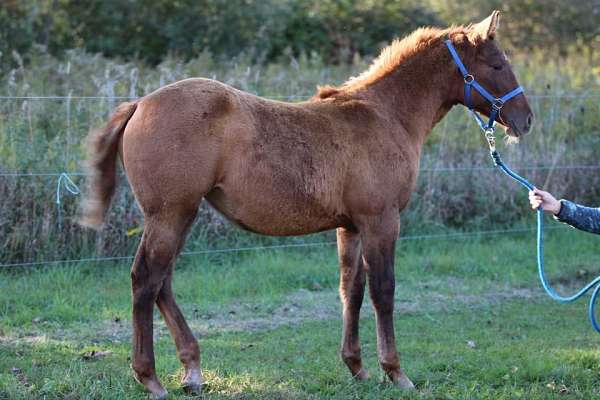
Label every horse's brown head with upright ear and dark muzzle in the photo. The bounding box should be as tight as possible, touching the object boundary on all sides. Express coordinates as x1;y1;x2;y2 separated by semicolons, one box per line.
452;11;533;137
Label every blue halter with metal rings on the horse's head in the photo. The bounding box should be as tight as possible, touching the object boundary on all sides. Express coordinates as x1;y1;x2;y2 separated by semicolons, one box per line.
444;39;523;148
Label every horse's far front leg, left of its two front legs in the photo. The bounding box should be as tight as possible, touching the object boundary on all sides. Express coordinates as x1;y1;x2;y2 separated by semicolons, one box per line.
337;228;368;380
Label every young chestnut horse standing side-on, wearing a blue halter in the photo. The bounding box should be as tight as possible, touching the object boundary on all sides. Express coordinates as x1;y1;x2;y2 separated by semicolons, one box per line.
81;11;533;398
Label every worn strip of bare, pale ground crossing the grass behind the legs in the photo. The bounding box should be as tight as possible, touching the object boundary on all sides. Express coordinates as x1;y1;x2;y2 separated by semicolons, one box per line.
3;281;542;344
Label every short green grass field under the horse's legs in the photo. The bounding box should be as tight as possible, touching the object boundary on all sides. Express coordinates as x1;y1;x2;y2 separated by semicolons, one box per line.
0;225;600;399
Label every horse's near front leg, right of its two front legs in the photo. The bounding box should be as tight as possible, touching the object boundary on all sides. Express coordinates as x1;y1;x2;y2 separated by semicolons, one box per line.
359;214;414;389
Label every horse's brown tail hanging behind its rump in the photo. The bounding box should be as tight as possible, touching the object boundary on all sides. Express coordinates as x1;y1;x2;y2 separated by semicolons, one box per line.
79;102;137;229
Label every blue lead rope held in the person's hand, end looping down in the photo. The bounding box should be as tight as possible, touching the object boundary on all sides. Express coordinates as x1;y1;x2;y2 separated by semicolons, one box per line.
490;148;600;333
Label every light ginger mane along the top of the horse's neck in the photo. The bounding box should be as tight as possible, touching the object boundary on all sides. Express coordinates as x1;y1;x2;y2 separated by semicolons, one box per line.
315;26;469;99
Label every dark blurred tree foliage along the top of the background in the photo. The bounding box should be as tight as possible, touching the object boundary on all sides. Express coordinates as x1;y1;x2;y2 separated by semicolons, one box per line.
0;0;600;70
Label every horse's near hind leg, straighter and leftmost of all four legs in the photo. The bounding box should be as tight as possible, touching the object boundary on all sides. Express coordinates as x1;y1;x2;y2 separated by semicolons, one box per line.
131;207;199;398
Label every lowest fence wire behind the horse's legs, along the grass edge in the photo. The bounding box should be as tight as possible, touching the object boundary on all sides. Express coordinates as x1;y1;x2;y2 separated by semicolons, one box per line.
0;226;567;268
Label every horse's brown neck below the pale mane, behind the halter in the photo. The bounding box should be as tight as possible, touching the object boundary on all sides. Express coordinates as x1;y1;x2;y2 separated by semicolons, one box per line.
367;47;457;146
